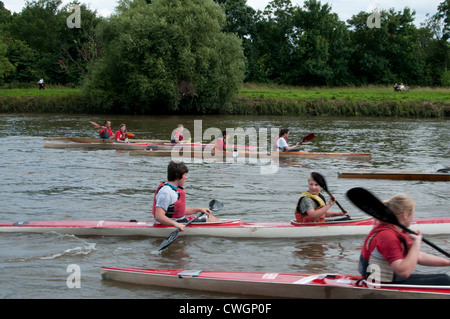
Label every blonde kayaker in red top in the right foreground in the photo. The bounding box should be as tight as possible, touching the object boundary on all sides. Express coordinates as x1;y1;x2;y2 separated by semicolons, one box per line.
358;194;450;286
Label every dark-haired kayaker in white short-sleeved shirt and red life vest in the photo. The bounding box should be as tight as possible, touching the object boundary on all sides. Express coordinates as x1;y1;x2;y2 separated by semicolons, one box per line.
152;161;219;231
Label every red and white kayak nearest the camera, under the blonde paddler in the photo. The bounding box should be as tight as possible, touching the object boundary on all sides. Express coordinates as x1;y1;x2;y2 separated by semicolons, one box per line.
100;267;450;299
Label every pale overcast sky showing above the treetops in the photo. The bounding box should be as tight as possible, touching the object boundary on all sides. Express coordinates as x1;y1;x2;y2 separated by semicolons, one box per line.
0;0;444;25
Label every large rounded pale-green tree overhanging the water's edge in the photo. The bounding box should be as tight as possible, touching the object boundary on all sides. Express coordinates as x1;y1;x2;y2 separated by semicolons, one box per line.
85;0;244;113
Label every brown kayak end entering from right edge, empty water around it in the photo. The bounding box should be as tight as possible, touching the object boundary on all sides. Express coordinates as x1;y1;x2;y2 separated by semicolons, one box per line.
338;172;450;181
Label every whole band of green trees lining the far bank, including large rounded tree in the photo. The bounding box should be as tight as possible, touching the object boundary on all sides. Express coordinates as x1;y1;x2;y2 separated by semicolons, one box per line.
0;0;450;113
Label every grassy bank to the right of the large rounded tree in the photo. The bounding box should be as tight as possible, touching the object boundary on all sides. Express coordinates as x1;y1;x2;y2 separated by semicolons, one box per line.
228;84;450;117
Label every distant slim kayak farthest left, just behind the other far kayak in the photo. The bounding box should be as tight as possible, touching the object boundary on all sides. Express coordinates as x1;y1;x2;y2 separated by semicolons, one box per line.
44;140;205;152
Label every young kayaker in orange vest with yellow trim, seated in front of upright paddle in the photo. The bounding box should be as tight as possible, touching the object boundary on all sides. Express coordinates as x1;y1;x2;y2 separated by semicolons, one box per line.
295;176;348;223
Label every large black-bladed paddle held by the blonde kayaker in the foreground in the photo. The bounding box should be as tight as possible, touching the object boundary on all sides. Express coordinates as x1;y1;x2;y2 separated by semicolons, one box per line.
347;187;450;258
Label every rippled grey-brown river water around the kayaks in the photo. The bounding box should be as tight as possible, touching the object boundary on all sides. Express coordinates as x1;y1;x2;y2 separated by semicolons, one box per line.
0;114;450;299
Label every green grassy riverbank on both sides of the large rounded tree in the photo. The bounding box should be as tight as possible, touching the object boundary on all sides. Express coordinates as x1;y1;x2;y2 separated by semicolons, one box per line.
0;83;450;118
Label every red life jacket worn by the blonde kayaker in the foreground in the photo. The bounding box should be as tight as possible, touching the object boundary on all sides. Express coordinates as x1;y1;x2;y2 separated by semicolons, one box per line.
358;224;408;282
